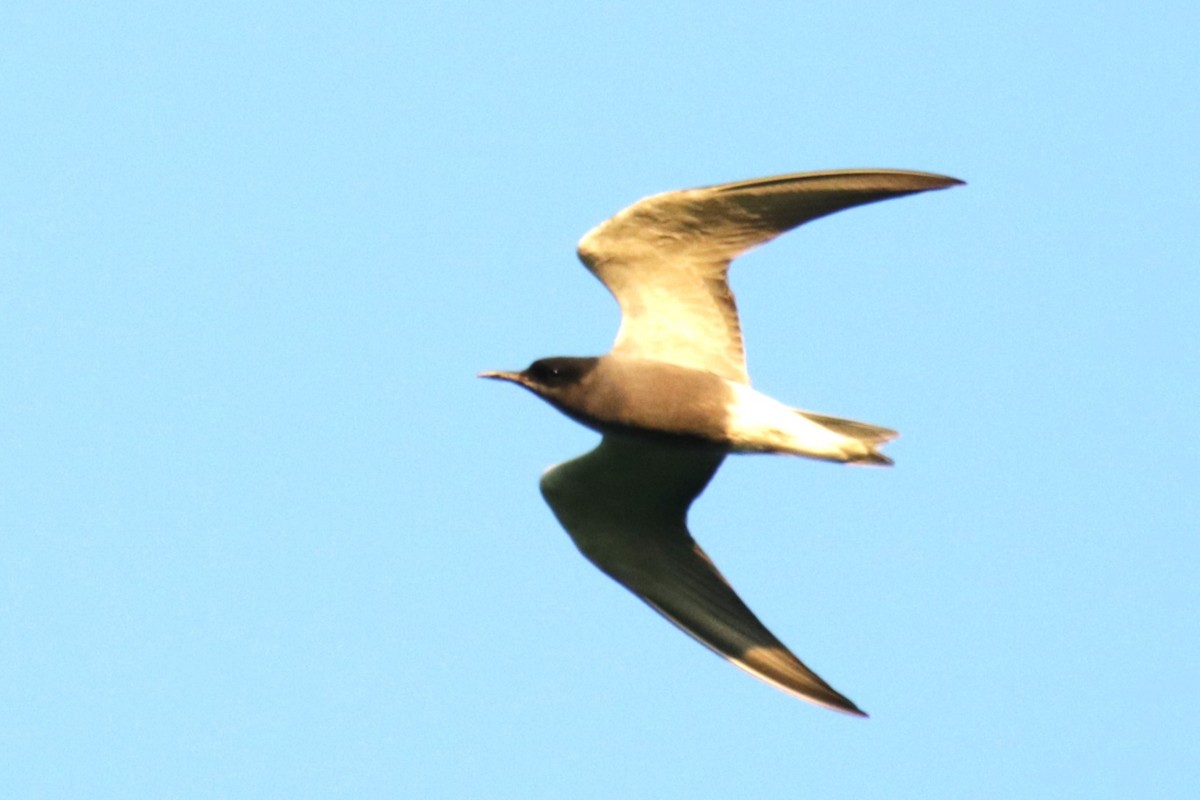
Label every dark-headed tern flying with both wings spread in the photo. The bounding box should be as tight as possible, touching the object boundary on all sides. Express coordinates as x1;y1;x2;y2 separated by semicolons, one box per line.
480;169;962;716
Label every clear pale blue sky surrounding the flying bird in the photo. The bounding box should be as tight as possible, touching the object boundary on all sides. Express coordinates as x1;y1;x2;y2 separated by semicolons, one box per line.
0;0;1200;799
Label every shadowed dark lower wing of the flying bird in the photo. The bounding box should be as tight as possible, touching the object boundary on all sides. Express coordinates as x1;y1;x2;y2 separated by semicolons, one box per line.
541;435;866;716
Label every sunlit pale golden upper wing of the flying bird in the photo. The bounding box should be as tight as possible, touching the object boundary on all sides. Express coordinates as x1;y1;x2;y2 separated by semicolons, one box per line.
578;169;962;383
